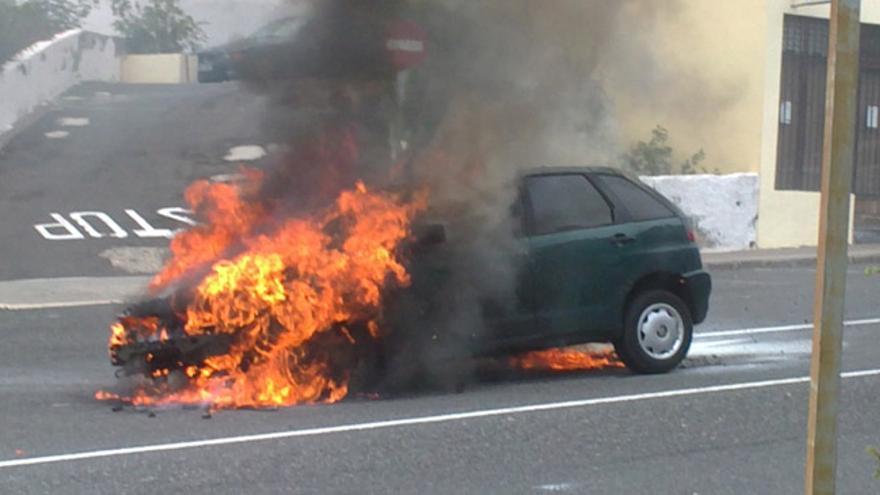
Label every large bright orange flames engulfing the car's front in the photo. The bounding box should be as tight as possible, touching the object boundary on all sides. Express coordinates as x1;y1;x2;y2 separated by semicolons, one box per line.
103;171;424;408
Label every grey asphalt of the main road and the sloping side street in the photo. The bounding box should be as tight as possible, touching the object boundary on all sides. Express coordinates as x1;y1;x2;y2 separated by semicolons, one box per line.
0;85;880;495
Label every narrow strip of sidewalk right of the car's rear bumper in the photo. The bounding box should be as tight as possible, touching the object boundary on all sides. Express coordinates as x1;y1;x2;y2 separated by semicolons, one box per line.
702;244;880;271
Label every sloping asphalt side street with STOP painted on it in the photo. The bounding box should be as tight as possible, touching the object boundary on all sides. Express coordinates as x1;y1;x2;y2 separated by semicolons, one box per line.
0;84;269;280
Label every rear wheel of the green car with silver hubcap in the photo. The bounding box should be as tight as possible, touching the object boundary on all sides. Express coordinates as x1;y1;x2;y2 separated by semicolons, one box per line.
614;290;694;374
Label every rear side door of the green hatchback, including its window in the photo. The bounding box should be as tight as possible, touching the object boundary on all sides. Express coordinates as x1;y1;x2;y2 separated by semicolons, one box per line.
524;173;620;341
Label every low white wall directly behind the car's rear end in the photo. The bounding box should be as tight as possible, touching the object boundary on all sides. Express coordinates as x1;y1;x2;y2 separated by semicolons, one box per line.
642;174;759;251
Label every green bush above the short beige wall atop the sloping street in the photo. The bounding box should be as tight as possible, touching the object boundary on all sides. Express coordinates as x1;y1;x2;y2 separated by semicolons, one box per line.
111;0;205;53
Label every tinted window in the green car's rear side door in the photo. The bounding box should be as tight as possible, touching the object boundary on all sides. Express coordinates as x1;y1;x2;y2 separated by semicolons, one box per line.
525;174;613;235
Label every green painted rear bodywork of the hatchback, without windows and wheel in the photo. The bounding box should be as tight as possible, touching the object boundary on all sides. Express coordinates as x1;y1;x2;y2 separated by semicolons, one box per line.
526;168;711;341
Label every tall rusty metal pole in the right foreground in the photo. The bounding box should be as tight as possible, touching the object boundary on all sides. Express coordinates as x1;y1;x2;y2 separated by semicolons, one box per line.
805;0;860;495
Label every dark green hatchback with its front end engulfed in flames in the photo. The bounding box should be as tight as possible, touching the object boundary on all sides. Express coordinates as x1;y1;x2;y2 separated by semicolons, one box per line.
101;168;711;407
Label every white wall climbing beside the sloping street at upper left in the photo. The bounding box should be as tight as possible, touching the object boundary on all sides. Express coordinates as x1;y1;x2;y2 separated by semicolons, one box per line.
0;29;119;134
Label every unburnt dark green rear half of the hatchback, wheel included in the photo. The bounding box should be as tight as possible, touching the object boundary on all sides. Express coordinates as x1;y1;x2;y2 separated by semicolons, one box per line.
396;168;712;372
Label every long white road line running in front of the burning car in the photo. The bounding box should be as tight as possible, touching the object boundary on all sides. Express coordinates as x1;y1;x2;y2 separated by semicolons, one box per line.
0;369;880;469
